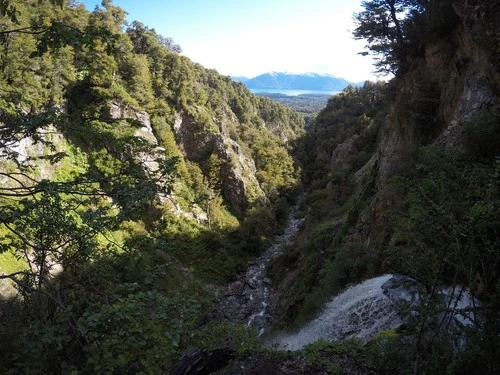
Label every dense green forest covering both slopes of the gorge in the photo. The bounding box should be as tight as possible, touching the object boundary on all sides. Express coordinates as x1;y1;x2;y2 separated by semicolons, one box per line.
0;0;500;374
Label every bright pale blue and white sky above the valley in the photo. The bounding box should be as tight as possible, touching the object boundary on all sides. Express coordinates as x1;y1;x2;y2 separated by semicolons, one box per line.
82;0;376;82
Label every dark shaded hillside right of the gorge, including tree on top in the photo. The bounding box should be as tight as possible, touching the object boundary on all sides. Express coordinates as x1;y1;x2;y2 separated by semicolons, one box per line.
269;0;500;374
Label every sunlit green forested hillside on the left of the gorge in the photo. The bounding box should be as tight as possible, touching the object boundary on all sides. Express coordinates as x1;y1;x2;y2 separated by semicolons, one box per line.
0;0;303;374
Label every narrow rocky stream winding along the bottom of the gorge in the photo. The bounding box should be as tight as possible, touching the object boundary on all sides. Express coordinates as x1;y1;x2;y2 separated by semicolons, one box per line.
217;199;303;336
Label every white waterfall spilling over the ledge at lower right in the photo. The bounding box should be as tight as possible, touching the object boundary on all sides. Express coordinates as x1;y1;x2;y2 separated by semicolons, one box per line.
267;274;478;350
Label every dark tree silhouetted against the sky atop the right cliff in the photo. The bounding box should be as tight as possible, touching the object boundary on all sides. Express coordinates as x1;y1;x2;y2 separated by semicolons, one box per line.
353;0;428;73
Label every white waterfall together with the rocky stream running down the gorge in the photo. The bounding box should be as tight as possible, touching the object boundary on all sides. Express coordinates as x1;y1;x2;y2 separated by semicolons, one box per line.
216;200;477;350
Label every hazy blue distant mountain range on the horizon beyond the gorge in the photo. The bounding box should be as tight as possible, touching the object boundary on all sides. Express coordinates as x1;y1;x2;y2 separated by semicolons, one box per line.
236;72;352;91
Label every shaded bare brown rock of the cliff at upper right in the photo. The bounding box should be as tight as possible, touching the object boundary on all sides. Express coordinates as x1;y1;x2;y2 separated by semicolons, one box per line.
356;1;500;244
